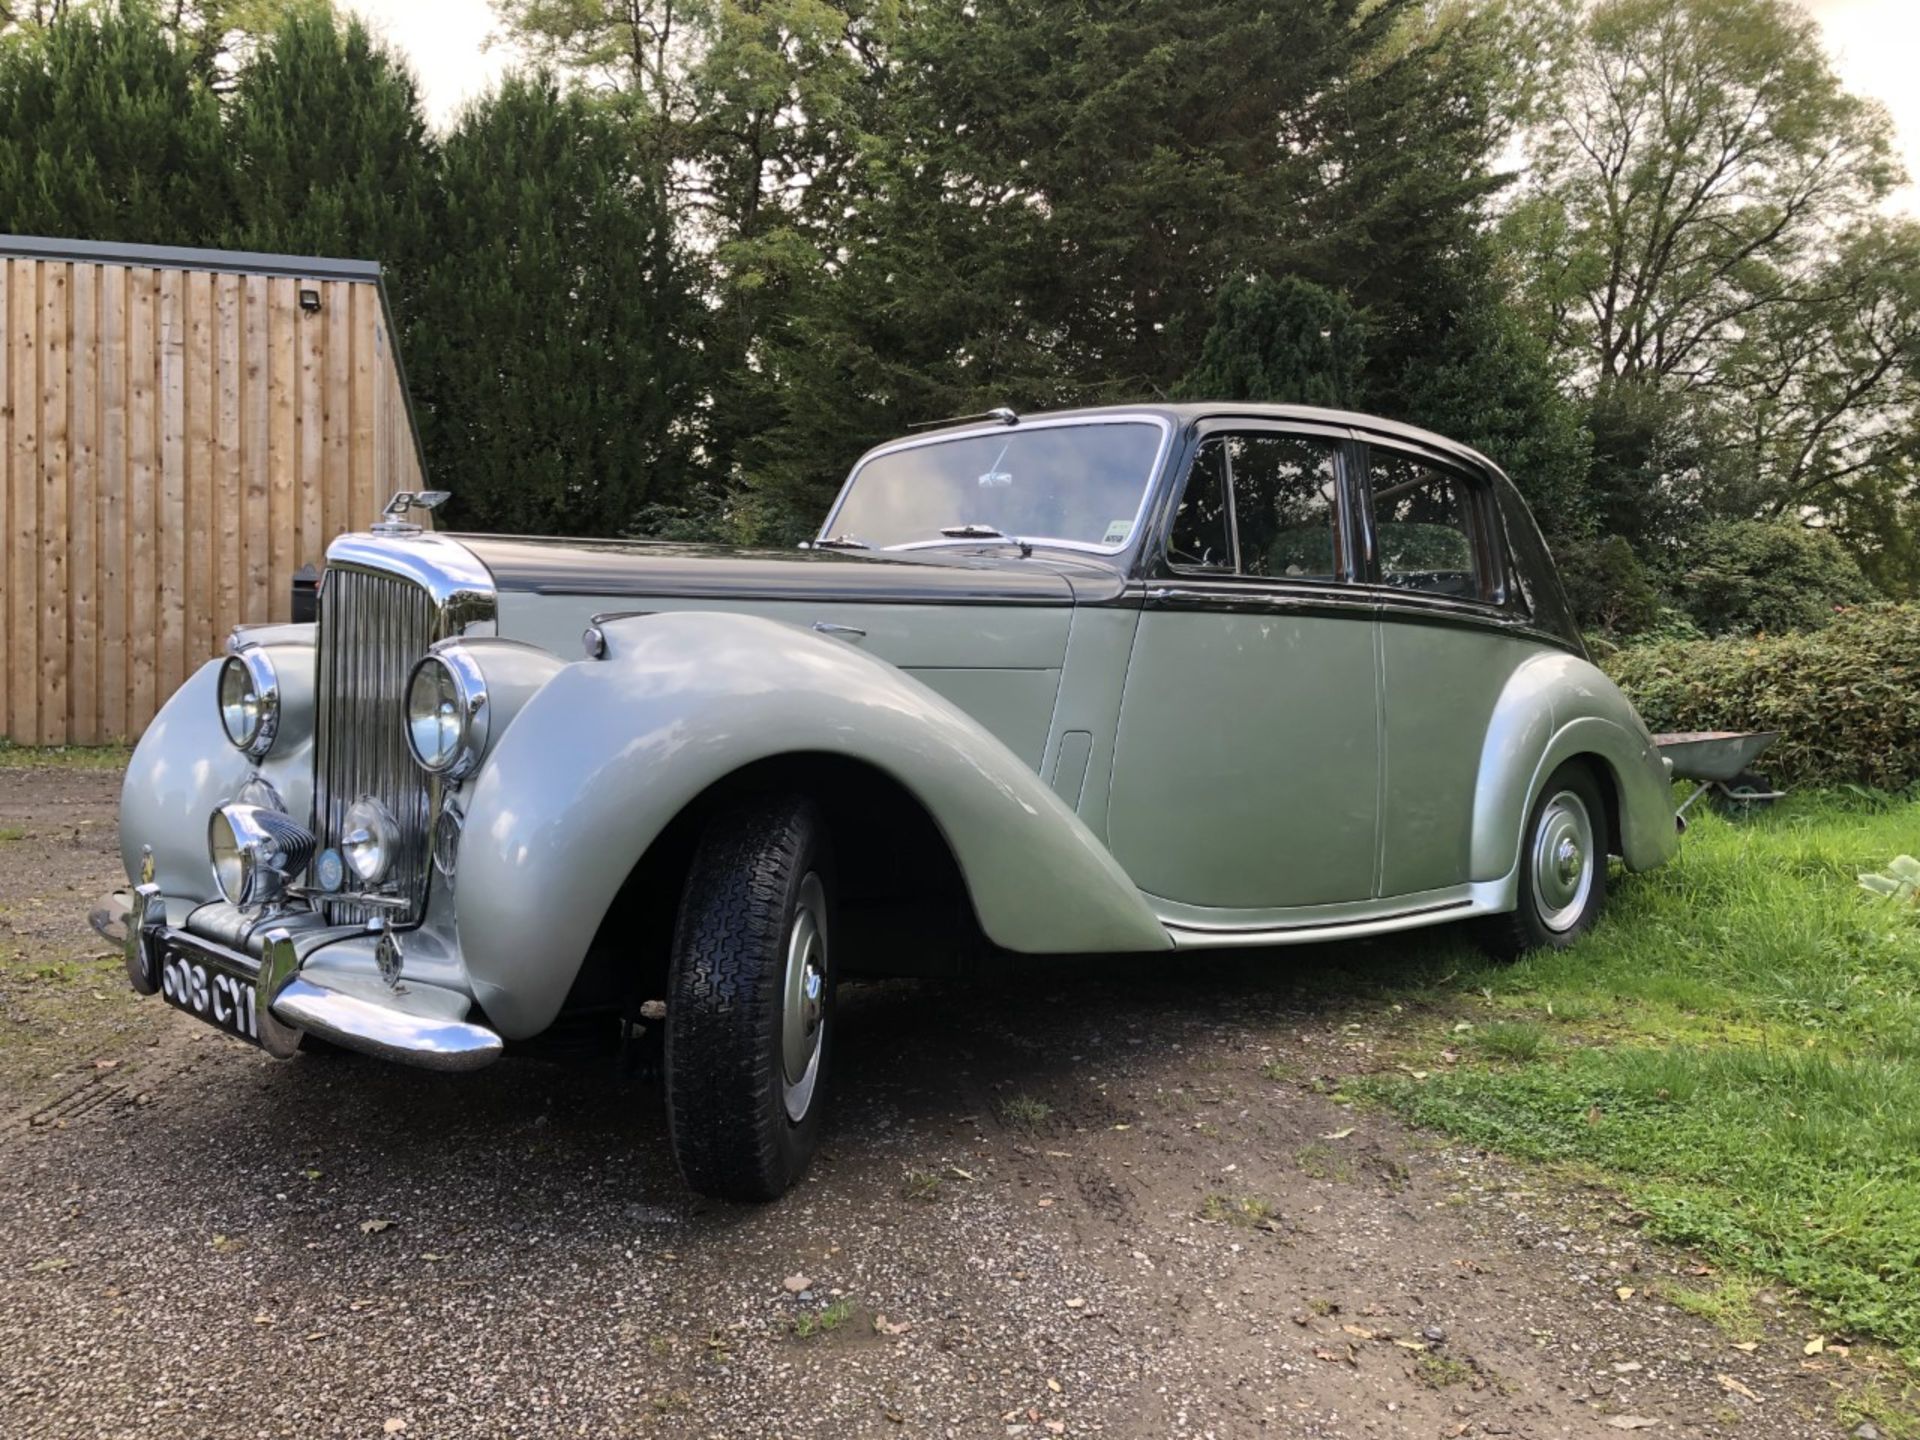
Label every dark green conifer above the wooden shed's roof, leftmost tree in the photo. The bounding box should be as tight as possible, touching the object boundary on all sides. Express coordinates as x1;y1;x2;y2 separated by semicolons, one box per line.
0;0;234;244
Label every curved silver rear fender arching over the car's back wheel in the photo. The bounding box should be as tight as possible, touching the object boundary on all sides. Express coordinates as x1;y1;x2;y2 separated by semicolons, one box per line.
1473;651;1678;881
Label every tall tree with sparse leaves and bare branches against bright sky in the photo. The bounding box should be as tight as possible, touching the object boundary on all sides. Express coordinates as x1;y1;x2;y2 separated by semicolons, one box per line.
1503;0;1920;549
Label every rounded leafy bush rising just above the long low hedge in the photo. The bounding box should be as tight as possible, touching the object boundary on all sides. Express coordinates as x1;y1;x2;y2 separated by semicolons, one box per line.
1678;520;1878;636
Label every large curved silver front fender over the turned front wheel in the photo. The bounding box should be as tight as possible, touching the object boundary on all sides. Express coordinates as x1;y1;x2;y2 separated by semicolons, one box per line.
457;611;1171;1039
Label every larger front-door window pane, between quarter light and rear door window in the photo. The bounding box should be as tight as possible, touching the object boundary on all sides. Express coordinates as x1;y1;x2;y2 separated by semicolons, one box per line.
1221;434;1340;582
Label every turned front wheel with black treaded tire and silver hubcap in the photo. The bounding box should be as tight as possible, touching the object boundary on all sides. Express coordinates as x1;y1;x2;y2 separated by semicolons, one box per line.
664;795;835;1202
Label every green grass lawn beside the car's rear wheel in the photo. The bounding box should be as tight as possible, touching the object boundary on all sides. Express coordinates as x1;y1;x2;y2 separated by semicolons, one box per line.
1352;797;1920;1365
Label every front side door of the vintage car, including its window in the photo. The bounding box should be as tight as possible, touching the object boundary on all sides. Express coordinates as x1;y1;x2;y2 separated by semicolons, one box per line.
1108;420;1380;906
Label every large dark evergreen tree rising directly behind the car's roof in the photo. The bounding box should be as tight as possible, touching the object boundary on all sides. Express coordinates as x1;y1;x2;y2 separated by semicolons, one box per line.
745;0;1528;537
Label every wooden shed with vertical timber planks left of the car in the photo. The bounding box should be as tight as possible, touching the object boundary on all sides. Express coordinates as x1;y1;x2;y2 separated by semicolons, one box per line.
0;236;422;745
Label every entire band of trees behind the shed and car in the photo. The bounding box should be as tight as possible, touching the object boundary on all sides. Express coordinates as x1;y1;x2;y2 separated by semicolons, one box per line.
0;0;1920;610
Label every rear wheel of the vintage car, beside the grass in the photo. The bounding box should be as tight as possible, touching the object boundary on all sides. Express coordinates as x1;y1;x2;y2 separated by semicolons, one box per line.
1478;760;1609;960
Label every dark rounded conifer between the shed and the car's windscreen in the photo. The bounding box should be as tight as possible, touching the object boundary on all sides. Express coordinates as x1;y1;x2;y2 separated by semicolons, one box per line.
405;75;699;534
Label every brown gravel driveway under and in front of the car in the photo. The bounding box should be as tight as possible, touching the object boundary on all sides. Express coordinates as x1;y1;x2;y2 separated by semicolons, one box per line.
0;768;1889;1438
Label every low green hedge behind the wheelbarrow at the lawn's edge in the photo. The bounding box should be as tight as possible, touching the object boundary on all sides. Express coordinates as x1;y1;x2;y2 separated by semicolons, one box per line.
1599;605;1920;789
